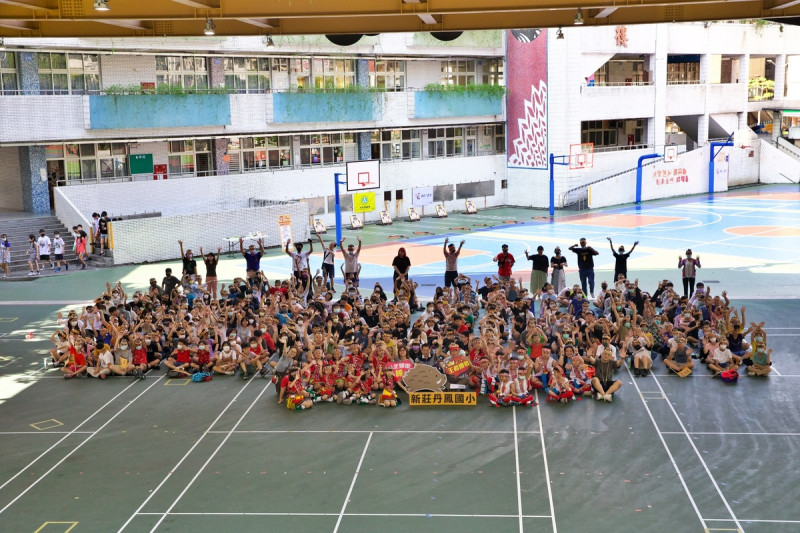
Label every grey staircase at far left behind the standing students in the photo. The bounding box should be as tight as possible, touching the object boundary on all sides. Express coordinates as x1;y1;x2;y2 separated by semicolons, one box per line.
0;216;114;278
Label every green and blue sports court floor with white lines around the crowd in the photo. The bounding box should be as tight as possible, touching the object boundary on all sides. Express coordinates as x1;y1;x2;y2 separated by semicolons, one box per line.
0;186;800;533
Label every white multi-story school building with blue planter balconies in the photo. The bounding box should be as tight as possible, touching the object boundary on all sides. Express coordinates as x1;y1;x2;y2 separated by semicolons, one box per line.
0;22;800;224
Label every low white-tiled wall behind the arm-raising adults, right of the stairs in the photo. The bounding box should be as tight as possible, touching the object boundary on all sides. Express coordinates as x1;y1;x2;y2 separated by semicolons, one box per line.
111;202;309;265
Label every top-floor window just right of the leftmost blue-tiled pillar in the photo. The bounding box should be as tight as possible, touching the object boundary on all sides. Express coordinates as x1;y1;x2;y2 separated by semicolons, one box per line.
36;52;100;94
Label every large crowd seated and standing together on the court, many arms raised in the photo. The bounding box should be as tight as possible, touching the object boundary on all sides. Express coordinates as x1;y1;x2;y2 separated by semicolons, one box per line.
48;235;772;410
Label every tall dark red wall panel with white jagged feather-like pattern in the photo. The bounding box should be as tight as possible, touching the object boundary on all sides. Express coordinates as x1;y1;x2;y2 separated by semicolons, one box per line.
505;28;548;169
